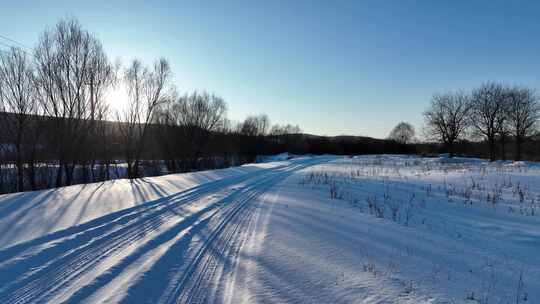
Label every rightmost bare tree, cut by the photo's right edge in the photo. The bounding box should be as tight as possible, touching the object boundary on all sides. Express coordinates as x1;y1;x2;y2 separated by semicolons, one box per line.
506;87;540;160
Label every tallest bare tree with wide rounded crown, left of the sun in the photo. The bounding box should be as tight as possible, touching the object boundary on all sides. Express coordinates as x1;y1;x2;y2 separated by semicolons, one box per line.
35;19;103;186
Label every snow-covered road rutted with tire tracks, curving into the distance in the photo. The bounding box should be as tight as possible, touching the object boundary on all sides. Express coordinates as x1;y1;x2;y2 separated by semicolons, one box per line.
0;157;329;304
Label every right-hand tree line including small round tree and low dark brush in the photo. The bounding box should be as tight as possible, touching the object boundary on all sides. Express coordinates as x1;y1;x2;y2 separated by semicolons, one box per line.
388;82;540;161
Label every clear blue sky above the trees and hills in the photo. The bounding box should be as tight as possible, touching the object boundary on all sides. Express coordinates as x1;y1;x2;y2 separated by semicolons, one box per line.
0;0;540;137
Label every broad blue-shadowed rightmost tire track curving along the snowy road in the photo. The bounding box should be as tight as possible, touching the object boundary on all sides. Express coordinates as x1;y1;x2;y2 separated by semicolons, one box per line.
113;160;318;303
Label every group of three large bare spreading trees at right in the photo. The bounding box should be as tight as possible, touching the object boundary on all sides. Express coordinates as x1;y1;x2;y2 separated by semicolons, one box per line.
424;83;540;161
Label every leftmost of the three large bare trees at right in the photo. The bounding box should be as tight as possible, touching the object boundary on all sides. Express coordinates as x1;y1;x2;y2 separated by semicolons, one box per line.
424;92;471;157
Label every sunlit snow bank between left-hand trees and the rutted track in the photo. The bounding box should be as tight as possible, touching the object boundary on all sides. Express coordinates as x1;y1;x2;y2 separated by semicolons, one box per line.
0;162;285;250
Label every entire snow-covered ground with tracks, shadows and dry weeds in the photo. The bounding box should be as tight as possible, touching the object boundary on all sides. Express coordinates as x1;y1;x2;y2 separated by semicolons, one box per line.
0;156;540;304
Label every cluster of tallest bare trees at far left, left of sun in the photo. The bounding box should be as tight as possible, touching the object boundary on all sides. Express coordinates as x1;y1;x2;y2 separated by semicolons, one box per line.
0;20;127;191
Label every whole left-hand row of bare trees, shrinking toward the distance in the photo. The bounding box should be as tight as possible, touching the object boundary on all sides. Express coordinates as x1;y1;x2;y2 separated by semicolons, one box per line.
0;19;308;192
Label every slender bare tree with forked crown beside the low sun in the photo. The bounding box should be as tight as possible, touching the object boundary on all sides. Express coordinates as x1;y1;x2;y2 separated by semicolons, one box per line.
117;58;171;178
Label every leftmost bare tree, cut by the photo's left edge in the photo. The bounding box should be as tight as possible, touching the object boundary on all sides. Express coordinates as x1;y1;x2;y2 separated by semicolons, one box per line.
0;48;37;191
